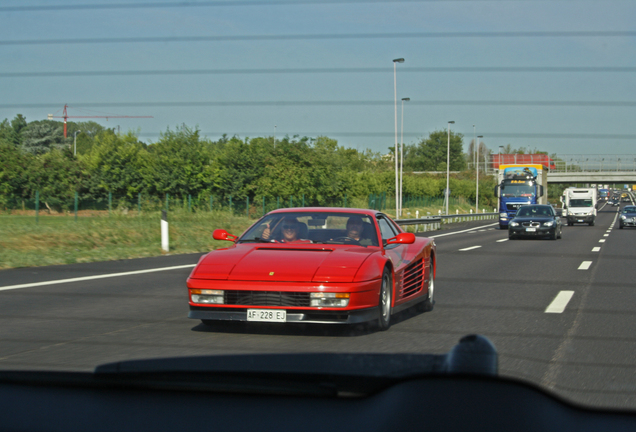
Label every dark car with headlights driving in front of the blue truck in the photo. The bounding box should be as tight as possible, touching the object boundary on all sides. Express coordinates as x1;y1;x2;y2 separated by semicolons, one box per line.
508;204;563;240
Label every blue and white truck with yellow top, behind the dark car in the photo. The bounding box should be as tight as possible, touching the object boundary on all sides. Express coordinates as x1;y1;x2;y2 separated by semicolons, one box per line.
495;164;548;229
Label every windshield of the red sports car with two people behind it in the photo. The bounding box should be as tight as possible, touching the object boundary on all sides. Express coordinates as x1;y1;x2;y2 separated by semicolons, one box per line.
239;212;379;246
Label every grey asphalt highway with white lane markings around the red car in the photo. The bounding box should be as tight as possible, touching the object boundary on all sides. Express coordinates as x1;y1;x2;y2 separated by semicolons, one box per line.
0;204;636;409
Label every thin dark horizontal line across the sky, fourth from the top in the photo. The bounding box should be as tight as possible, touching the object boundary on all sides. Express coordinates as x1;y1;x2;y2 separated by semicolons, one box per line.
0;100;636;109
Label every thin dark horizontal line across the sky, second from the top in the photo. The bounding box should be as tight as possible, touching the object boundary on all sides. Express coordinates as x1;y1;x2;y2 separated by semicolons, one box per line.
0;31;636;46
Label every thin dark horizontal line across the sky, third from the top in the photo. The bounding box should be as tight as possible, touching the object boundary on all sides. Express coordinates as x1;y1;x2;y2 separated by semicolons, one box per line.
0;66;636;78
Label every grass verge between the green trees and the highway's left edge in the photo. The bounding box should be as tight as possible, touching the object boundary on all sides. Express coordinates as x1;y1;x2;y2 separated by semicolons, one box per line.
0;211;253;269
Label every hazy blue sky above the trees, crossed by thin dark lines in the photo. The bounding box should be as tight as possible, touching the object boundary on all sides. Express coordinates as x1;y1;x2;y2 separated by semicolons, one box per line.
0;0;636;155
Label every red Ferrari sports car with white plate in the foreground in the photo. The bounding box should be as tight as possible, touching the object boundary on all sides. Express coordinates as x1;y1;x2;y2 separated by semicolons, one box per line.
187;207;437;330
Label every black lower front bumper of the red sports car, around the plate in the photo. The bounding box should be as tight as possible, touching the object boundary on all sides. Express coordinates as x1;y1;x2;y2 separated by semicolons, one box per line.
188;306;380;324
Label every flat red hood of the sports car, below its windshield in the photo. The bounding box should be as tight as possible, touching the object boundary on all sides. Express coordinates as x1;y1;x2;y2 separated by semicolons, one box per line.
190;244;378;282
